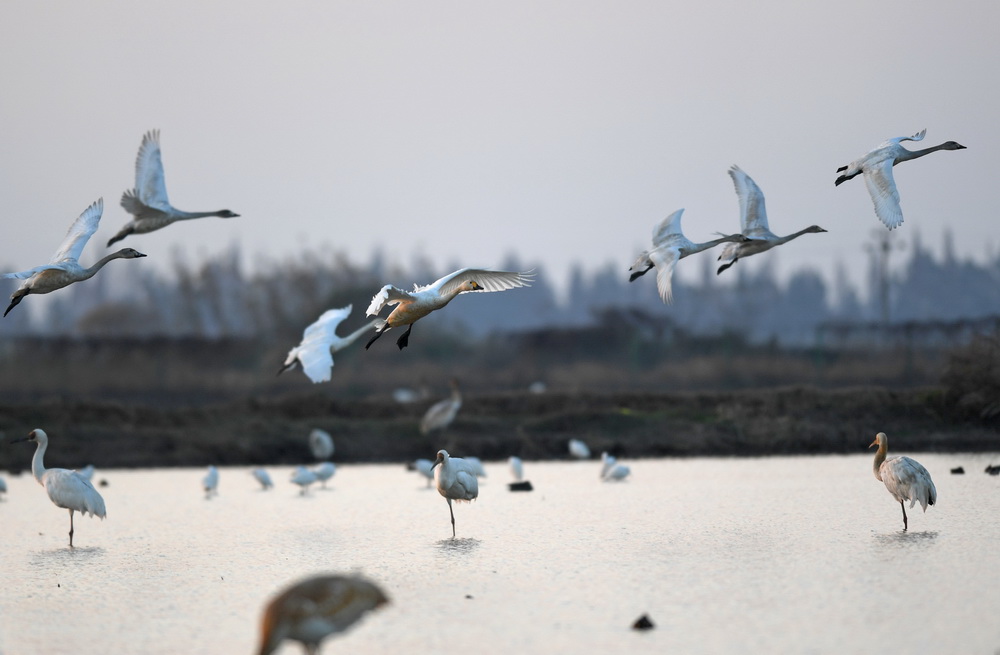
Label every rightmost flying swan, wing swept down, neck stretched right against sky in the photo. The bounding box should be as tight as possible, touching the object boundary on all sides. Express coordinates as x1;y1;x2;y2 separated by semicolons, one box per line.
833;129;965;230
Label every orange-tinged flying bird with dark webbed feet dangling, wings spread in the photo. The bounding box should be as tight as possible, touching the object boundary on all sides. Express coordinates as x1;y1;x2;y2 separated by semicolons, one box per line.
365;268;534;350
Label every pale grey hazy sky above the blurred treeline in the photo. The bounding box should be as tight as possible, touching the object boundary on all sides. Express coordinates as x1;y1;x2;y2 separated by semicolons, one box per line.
0;0;1000;306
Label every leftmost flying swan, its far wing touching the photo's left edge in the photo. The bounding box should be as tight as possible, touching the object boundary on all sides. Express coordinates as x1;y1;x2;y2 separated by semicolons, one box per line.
0;198;146;316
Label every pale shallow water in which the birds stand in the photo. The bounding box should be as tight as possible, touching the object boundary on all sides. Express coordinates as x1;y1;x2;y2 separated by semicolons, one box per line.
0;455;1000;655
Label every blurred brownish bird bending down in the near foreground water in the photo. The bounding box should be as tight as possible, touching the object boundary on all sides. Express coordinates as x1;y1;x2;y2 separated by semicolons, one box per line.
258;575;389;655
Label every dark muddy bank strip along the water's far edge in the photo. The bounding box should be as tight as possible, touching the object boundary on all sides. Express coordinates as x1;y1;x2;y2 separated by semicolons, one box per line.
0;388;1000;470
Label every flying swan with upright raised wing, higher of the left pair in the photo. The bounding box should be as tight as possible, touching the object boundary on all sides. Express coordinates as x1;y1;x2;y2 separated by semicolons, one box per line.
108;130;239;246
